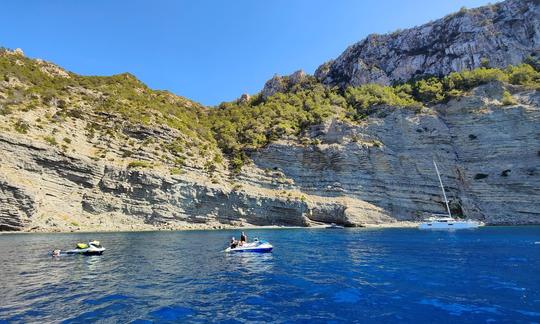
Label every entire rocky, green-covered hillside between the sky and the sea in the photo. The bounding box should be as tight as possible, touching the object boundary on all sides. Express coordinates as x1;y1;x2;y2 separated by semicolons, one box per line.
0;0;540;231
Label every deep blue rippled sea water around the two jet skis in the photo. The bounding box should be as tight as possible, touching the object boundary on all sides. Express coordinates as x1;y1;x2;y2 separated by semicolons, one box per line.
0;227;540;323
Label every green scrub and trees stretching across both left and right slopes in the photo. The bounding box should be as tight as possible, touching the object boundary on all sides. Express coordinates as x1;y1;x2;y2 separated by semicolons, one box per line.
0;47;540;173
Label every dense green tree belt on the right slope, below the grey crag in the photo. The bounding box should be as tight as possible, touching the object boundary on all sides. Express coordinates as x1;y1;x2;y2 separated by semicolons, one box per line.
209;64;540;169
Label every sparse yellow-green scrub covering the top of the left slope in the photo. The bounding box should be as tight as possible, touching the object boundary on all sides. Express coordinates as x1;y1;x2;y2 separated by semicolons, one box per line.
0;49;221;172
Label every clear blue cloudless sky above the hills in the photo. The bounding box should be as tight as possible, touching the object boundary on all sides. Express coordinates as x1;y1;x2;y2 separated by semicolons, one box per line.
0;0;496;105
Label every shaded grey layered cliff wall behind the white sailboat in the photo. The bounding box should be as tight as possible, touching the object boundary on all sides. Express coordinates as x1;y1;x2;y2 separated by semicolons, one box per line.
249;83;540;224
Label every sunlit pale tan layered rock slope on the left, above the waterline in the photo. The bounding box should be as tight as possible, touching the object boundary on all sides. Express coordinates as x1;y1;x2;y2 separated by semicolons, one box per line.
0;135;350;231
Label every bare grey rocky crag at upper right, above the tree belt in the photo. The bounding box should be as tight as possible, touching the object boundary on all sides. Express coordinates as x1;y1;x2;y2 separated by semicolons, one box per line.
315;0;540;87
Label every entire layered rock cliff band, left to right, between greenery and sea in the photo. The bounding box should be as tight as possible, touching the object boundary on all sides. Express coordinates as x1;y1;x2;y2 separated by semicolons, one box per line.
0;83;540;231
